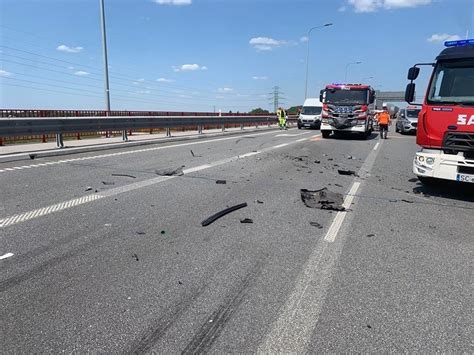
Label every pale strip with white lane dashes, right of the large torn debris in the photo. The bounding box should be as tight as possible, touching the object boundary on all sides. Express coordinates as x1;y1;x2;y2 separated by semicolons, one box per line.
258;139;380;354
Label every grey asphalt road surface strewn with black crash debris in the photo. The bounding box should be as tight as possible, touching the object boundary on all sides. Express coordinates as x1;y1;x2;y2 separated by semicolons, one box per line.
0;129;474;353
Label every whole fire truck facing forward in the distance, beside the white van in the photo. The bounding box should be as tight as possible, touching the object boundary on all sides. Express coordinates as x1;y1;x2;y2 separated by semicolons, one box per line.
319;84;375;138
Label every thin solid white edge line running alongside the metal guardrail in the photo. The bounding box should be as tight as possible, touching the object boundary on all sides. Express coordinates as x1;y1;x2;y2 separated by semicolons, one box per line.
0;131;282;173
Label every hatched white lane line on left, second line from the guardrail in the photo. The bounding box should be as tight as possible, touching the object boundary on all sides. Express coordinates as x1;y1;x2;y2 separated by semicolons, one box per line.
0;135;320;228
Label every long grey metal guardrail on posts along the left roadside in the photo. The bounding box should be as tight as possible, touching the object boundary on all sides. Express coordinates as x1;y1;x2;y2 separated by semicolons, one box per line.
0;116;276;147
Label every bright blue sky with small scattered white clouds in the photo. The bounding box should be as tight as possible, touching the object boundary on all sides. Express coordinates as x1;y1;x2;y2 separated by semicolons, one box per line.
0;0;474;112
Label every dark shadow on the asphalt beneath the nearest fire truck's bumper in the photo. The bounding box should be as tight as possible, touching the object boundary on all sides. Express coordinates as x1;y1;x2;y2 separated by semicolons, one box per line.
413;181;474;202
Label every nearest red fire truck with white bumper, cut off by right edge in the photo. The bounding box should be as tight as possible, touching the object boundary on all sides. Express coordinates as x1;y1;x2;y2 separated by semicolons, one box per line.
405;39;474;183
